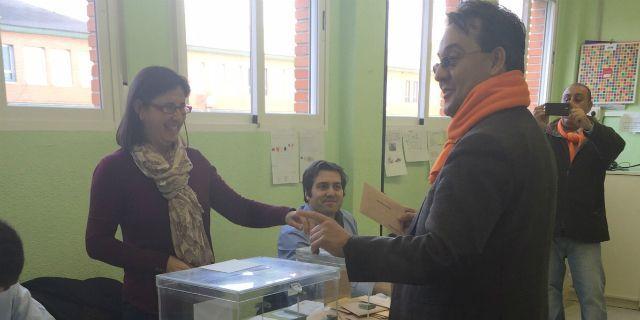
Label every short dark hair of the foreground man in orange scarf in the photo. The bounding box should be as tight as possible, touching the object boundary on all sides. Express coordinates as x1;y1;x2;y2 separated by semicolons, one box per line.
447;0;526;72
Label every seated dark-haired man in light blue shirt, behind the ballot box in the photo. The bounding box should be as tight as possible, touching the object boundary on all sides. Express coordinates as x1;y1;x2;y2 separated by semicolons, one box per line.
278;160;373;296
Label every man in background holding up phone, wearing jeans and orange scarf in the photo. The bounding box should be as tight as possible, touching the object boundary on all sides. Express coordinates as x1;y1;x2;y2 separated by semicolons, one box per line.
533;83;625;319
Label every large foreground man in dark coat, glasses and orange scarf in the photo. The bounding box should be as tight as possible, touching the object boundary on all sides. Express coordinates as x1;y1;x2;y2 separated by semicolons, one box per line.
305;1;557;320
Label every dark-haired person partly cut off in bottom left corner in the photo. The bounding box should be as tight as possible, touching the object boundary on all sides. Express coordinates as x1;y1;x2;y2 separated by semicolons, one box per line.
0;220;53;320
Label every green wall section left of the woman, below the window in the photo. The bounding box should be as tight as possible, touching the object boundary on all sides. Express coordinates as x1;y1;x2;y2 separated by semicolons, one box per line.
0;131;120;280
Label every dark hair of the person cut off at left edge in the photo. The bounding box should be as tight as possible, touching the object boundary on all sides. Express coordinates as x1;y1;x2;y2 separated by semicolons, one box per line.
0;220;24;289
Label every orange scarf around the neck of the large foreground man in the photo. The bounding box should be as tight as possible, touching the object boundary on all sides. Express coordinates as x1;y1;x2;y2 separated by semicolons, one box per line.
429;70;530;184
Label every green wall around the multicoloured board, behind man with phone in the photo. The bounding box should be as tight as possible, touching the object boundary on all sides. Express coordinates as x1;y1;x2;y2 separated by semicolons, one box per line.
551;0;640;164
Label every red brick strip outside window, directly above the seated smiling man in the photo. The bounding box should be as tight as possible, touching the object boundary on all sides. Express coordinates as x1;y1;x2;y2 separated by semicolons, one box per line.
294;0;311;113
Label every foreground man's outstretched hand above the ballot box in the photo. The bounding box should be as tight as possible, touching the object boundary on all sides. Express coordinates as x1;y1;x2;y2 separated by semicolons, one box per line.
300;211;351;257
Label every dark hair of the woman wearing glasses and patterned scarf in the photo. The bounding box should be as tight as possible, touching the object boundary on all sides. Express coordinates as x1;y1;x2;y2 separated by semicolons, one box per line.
116;66;191;151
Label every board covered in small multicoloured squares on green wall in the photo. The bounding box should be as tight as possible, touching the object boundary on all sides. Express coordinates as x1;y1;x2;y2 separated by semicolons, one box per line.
578;42;640;104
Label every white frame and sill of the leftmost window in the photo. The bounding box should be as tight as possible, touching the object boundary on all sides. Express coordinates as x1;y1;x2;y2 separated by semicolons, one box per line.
0;0;122;131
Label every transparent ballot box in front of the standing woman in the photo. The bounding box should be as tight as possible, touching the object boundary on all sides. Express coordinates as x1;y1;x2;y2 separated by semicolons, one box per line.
156;257;340;320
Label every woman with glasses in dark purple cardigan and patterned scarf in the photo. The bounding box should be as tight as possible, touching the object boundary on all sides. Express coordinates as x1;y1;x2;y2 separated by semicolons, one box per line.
86;67;303;319
